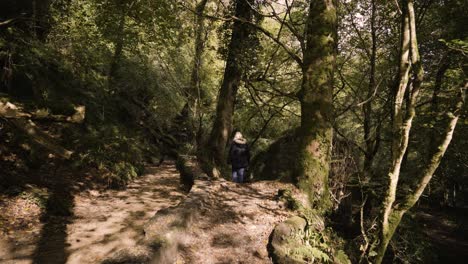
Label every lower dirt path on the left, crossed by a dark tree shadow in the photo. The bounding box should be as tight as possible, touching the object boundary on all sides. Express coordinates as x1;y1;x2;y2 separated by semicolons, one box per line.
0;165;185;264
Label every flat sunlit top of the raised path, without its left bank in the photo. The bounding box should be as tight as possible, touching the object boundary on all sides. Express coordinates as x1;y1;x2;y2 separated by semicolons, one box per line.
178;181;294;264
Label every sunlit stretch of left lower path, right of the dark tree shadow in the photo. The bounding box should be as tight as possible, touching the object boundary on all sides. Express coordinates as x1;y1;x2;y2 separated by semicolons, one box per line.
68;166;184;263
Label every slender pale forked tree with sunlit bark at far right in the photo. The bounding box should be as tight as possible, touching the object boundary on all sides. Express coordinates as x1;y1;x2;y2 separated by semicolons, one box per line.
370;0;467;263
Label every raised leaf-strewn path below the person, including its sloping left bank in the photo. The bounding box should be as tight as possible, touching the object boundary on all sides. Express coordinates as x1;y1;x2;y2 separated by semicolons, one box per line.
132;171;297;264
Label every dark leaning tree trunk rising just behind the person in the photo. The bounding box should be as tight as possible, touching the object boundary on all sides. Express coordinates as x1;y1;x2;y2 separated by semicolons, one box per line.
207;0;254;174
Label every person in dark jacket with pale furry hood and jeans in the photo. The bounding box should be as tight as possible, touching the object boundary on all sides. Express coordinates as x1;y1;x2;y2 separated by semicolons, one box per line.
228;131;250;183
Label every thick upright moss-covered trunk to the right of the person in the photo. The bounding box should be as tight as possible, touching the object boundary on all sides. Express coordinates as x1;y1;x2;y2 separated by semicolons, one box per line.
296;0;337;208
